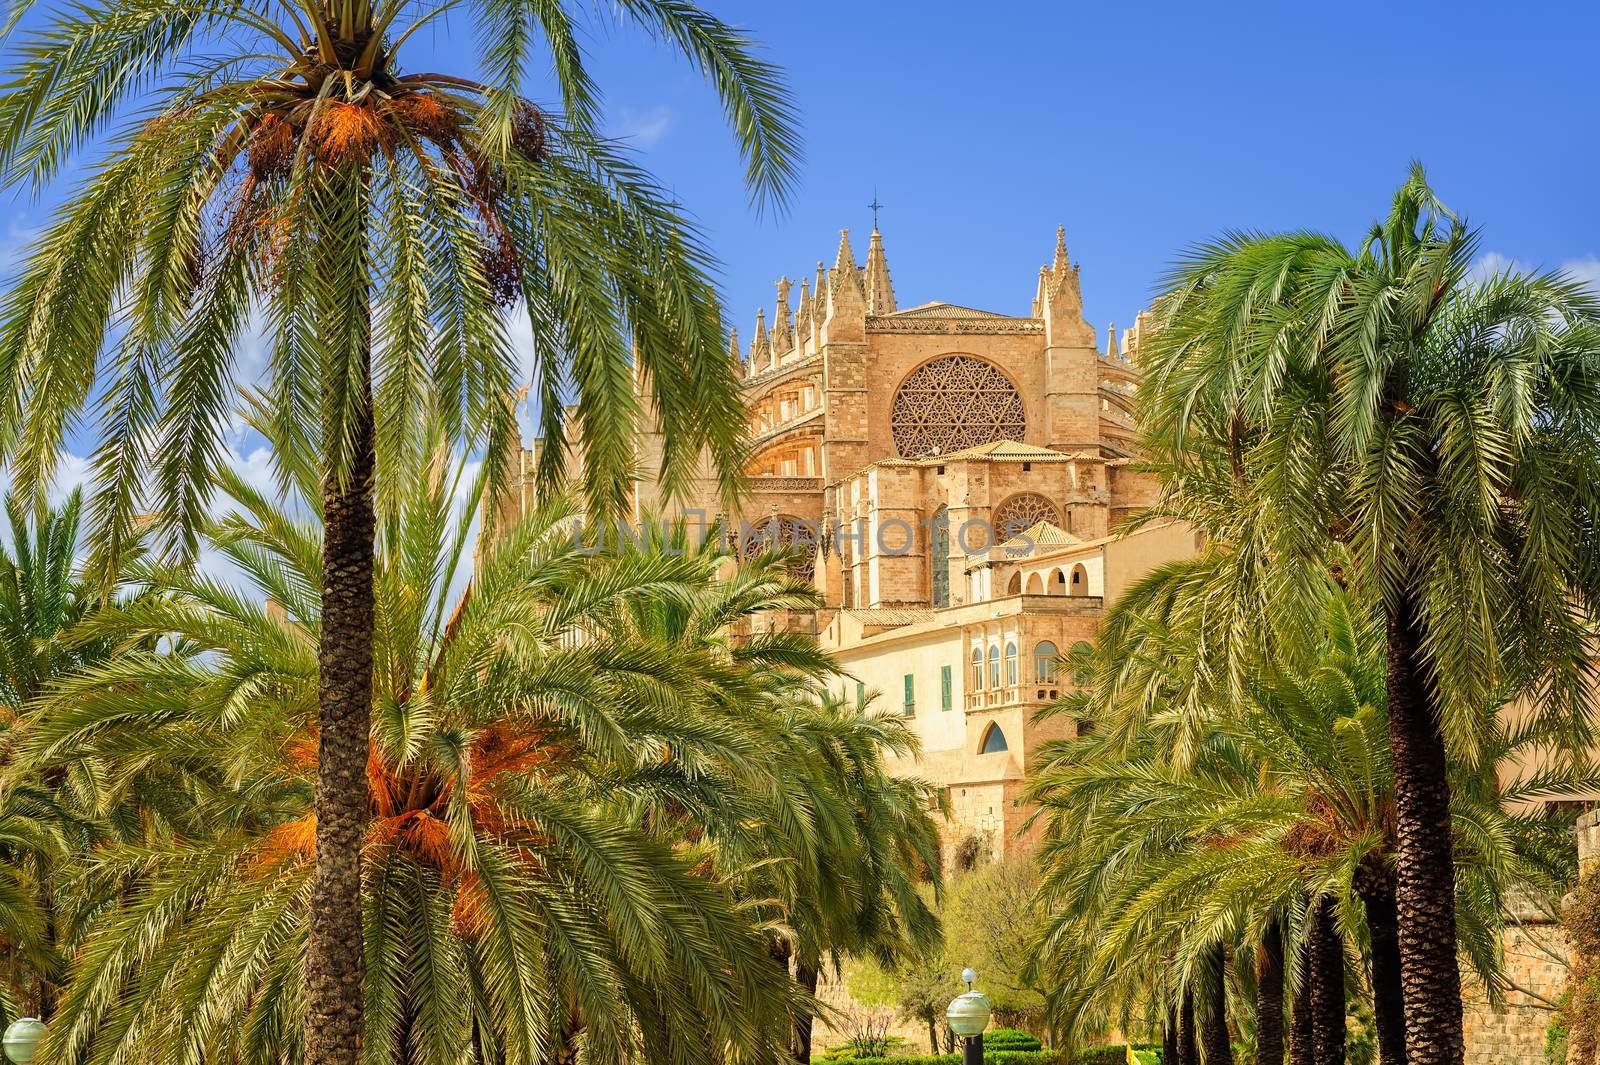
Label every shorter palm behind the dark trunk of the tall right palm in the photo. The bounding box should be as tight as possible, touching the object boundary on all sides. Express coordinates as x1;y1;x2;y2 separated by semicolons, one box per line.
1030;572;1573;1065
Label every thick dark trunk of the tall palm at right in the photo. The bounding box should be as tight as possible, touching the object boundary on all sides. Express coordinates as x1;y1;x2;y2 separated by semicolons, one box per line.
1389;595;1464;1065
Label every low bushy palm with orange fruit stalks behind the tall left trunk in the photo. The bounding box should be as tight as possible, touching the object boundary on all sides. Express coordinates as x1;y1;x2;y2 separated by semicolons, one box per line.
18;415;864;1065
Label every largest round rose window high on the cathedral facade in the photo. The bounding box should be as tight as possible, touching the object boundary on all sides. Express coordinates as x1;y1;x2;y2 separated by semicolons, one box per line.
890;355;1027;459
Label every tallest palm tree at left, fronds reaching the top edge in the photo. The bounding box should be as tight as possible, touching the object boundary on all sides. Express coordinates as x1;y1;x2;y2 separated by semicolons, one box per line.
0;0;795;1065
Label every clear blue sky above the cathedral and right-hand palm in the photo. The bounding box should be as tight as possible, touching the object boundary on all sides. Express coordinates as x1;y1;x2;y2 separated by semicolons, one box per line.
476;0;1600;332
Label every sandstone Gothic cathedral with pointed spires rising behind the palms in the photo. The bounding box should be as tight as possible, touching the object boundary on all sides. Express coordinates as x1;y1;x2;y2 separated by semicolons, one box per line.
492;229;1194;862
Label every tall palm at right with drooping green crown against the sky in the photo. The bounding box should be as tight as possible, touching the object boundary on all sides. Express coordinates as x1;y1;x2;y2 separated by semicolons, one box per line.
1141;168;1600;1065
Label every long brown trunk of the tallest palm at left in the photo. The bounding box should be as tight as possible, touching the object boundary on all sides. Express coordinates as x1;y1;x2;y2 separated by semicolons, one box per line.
306;352;374;1065
